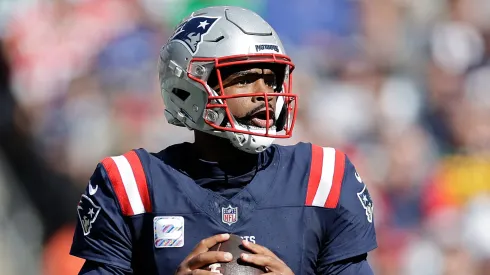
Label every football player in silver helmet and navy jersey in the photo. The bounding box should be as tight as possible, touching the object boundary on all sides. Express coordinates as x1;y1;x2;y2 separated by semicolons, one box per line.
71;6;377;275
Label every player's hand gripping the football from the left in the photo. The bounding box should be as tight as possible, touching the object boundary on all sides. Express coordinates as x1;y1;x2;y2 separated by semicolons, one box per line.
175;234;233;275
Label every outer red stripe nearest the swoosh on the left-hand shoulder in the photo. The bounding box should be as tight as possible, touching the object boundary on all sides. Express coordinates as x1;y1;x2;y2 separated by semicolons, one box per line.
102;158;134;216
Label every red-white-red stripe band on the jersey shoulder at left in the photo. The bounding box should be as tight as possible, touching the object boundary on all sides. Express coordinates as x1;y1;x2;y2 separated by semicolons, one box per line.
102;151;151;216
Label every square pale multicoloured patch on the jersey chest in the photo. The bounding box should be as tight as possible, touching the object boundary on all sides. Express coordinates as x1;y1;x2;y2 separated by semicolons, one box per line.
153;216;184;248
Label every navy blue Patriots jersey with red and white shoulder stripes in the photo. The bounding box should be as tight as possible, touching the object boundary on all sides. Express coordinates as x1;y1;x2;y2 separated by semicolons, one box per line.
71;143;377;275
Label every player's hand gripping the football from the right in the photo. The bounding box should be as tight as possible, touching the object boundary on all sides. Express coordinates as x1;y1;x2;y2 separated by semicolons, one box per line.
240;240;294;275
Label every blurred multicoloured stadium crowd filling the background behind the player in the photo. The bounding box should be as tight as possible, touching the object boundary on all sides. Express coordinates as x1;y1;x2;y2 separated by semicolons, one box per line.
0;0;490;275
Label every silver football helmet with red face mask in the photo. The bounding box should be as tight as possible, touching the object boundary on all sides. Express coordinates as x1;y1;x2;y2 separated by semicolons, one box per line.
158;6;297;153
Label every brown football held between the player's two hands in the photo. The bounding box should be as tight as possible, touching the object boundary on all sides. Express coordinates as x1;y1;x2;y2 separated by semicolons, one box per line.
205;234;265;275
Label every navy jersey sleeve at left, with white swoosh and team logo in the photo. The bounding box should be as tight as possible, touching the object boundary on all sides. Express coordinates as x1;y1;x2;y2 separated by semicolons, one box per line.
70;163;132;274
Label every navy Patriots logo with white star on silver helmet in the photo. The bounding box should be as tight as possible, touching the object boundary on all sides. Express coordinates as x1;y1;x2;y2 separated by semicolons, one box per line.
170;16;219;55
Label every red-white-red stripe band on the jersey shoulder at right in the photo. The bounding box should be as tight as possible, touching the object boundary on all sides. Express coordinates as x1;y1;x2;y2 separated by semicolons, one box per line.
306;145;345;208
